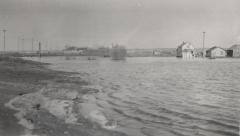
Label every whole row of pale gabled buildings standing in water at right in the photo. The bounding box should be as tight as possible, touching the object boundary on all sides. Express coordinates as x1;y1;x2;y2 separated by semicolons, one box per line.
176;42;240;59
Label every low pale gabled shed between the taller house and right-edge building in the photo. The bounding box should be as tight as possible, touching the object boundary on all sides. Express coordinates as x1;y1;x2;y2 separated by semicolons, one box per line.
206;46;227;58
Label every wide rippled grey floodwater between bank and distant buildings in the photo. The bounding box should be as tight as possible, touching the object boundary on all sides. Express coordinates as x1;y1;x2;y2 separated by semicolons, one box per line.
27;57;240;136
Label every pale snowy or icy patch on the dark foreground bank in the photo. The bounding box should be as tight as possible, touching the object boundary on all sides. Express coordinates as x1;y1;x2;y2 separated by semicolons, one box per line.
5;85;116;136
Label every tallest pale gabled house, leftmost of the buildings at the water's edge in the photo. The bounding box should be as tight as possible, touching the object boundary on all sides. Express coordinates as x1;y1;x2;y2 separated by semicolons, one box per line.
176;42;194;59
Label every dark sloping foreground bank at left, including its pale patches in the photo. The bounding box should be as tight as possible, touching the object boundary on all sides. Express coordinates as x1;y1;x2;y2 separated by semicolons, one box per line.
0;57;125;136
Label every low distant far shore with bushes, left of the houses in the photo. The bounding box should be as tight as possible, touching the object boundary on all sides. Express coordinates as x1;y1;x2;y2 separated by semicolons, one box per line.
0;45;190;59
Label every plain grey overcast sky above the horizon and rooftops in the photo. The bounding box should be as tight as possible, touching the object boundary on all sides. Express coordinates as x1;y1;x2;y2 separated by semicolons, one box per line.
0;0;240;50
